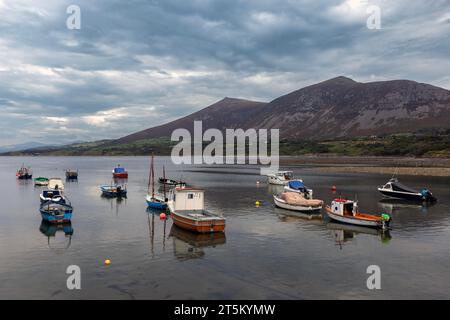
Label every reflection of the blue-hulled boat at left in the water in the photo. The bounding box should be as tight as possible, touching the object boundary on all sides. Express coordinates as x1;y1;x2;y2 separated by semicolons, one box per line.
39;220;73;253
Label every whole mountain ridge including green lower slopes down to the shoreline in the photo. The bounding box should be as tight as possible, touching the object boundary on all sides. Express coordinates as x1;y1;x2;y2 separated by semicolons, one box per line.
1;77;450;158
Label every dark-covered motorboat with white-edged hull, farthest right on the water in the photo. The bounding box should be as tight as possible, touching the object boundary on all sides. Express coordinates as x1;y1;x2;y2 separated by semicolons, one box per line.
378;178;437;202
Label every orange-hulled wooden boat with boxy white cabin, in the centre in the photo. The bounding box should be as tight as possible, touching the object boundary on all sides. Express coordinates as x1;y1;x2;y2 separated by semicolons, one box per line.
168;188;225;233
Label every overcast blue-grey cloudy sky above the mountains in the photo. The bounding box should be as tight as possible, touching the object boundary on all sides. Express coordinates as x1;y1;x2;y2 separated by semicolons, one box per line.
0;0;450;145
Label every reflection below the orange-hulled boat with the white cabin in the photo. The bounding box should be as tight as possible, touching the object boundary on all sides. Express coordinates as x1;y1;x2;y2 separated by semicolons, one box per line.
170;225;227;261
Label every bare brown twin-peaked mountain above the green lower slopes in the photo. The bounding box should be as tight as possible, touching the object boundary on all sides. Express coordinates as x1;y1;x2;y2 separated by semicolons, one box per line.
113;77;450;144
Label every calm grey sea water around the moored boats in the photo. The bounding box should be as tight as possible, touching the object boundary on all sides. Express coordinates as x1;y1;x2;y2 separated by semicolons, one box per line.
0;157;450;299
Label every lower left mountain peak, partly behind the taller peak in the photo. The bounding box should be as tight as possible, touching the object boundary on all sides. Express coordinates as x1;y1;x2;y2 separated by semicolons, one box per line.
113;98;266;143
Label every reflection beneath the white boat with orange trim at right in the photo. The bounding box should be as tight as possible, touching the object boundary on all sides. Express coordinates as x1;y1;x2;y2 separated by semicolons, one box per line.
327;222;392;249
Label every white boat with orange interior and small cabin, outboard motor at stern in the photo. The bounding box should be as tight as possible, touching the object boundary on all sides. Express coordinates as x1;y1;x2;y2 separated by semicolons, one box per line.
325;198;391;229
